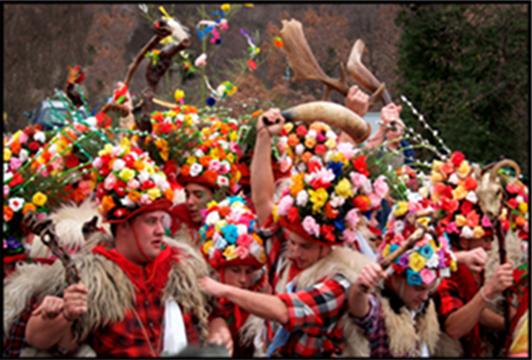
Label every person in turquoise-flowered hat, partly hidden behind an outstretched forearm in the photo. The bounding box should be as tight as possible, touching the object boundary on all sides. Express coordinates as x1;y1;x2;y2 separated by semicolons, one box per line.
200;196;270;357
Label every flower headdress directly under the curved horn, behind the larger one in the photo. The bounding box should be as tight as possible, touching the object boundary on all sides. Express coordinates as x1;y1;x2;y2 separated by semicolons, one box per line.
274;121;338;174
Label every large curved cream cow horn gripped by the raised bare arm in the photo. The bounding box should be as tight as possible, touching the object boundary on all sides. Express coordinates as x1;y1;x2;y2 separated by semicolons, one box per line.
282;101;371;144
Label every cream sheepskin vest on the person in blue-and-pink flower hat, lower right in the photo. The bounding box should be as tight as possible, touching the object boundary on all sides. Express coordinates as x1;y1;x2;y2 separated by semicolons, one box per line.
342;295;440;357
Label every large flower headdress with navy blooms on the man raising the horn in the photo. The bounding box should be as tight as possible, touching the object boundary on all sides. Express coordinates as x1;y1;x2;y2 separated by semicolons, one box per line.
273;144;389;245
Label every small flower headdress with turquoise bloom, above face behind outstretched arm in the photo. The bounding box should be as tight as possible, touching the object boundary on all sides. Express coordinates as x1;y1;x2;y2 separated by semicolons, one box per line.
199;196;266;268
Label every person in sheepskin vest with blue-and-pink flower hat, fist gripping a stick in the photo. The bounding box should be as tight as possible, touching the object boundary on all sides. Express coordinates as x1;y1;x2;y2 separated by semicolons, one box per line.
348;199;456;357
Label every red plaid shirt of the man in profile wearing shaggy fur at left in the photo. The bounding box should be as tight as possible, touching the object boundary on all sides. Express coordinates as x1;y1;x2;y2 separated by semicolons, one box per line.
88;247;199;357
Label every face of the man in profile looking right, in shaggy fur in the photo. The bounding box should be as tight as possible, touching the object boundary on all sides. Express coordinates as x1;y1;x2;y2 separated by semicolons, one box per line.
130;210;170;261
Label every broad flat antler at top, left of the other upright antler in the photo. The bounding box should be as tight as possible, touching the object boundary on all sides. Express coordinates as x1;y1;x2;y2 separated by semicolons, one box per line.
281;19;349;96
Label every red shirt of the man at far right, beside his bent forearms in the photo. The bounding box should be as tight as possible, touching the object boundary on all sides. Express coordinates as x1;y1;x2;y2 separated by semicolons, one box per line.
435;263;486;357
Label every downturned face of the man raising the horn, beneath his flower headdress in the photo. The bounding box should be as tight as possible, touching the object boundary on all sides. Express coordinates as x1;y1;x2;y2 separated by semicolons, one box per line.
285;230;330;270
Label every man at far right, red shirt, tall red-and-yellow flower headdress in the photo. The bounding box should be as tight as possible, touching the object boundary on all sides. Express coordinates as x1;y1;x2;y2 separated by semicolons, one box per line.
424;151;512;356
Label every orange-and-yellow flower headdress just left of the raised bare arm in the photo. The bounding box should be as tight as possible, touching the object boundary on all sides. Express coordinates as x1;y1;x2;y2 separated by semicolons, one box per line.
179;118;242;191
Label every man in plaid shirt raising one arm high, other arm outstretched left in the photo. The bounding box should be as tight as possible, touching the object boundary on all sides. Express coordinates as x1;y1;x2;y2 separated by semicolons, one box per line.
201;109;382;357
